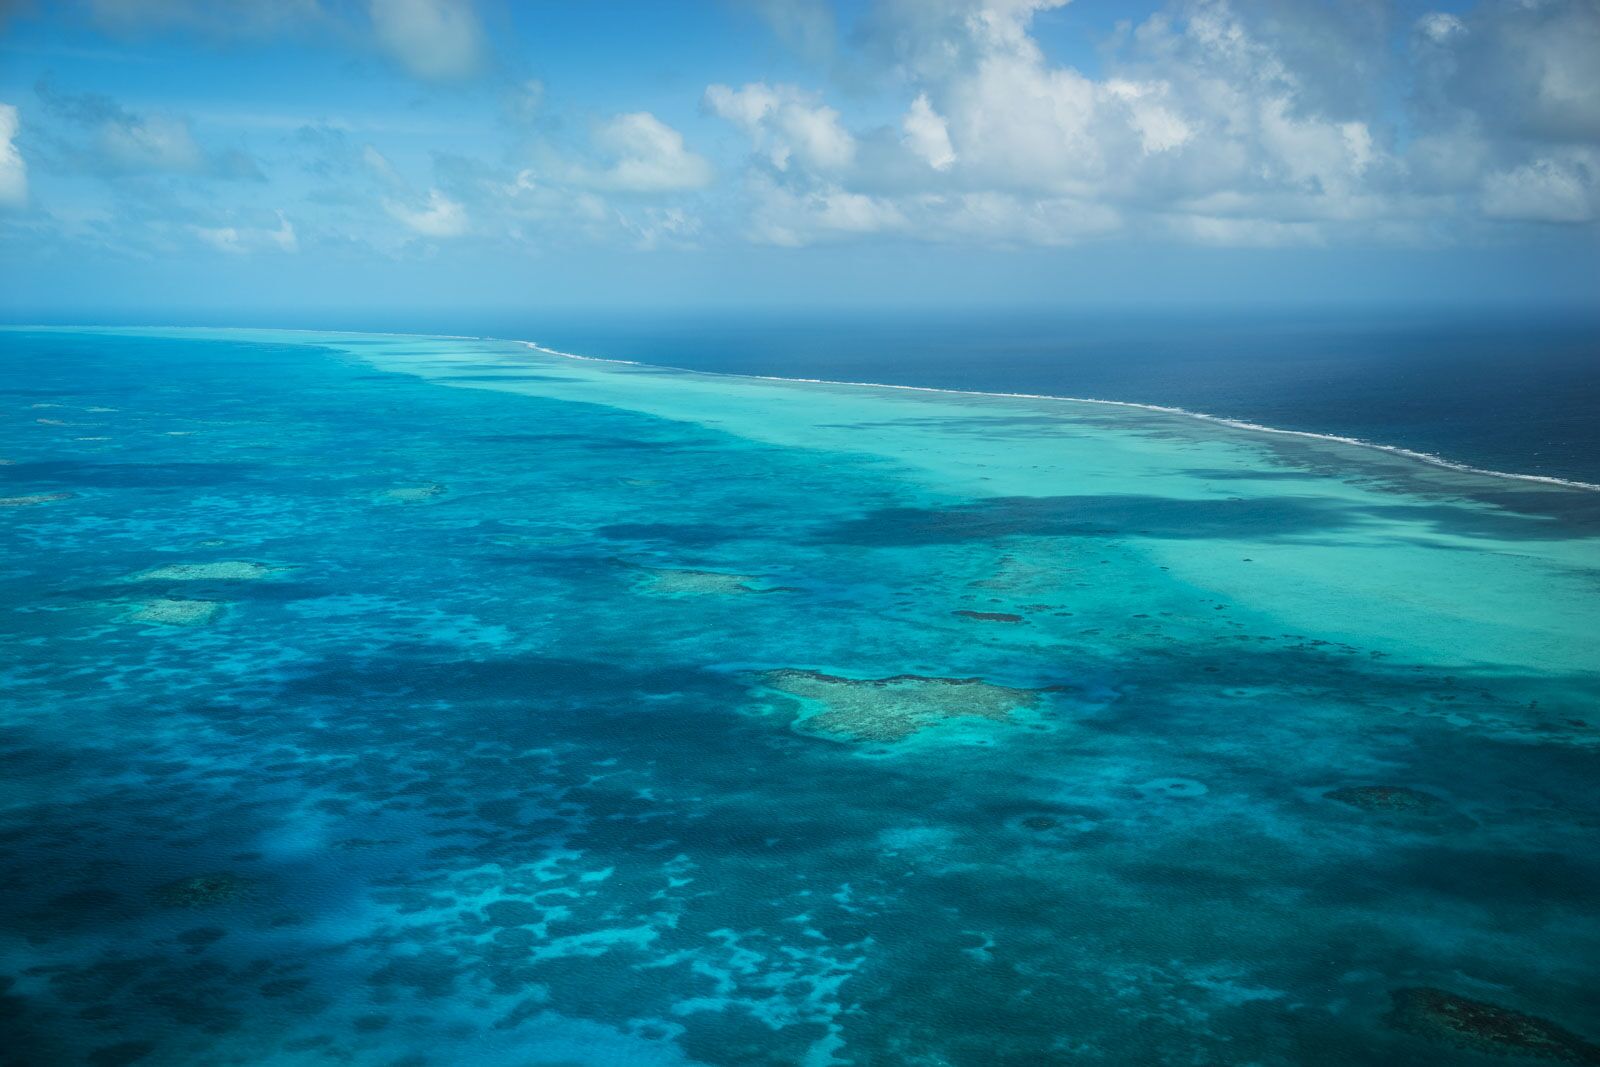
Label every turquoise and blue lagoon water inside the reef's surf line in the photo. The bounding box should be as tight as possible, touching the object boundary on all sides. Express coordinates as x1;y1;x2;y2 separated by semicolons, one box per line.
0;330;1600;1065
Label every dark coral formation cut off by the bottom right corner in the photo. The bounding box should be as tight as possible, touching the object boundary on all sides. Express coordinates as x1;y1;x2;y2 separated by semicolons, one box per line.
1386;985;1600;1064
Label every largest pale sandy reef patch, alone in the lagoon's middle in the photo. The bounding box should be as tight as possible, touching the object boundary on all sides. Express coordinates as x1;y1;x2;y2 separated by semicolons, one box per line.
762;667;1040;742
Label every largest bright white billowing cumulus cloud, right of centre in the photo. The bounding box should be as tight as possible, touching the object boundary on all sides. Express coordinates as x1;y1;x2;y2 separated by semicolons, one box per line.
706;0;1392;243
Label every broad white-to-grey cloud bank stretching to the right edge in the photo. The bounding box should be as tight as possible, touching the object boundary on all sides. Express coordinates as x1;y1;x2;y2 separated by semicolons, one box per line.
704;0;1600;245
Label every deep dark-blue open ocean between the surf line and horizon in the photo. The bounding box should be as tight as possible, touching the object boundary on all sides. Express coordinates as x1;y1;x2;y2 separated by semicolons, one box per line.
505;312;1600;483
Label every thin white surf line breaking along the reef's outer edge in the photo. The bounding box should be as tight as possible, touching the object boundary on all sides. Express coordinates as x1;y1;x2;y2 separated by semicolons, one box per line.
0;323;1600;493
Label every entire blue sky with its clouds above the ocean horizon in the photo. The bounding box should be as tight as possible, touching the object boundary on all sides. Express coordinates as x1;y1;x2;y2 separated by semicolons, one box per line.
0;0;1600;321
